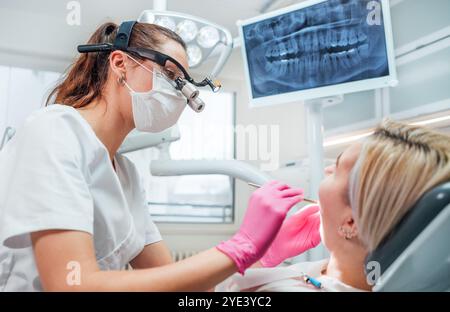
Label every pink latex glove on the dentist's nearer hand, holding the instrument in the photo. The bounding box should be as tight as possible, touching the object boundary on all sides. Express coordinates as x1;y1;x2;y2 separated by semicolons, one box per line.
217;181;303;274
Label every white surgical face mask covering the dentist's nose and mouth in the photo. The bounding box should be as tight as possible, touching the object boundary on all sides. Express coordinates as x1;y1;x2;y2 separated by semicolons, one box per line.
124;57;187;132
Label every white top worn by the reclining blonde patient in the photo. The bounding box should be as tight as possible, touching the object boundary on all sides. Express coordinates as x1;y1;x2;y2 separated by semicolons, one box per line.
215;259;364;292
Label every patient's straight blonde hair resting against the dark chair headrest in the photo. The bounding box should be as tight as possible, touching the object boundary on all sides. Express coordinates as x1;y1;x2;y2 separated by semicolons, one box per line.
349;119;450;252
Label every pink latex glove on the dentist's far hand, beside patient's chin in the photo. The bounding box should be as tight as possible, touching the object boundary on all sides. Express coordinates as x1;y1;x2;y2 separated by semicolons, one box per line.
260;204;320;267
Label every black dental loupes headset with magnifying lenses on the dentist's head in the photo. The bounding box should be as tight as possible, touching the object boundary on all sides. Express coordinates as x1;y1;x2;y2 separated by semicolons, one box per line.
77;21;221;113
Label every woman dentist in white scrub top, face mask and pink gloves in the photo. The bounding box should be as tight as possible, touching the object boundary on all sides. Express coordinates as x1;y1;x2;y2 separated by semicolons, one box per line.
0;23;320;291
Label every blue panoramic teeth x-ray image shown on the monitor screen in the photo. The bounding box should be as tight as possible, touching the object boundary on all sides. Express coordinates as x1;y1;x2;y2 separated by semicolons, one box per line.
243;0;389;98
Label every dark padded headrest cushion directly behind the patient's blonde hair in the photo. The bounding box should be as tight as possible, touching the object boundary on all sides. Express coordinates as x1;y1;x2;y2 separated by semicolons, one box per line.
365;182;450;274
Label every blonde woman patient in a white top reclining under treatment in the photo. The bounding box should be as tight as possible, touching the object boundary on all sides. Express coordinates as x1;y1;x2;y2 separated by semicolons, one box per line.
216;120;450;291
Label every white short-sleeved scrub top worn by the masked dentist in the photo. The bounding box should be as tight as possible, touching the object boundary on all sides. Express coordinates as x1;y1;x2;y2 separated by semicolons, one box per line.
0;104;161;291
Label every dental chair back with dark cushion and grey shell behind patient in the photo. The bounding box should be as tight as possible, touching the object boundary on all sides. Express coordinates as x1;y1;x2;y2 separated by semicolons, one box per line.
366;182;450;291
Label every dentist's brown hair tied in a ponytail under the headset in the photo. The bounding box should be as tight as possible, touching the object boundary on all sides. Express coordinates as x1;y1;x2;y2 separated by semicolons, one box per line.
45;23;186;108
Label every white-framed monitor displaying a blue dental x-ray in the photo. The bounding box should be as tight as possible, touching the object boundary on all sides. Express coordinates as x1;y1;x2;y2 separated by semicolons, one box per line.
238;0;397;106
